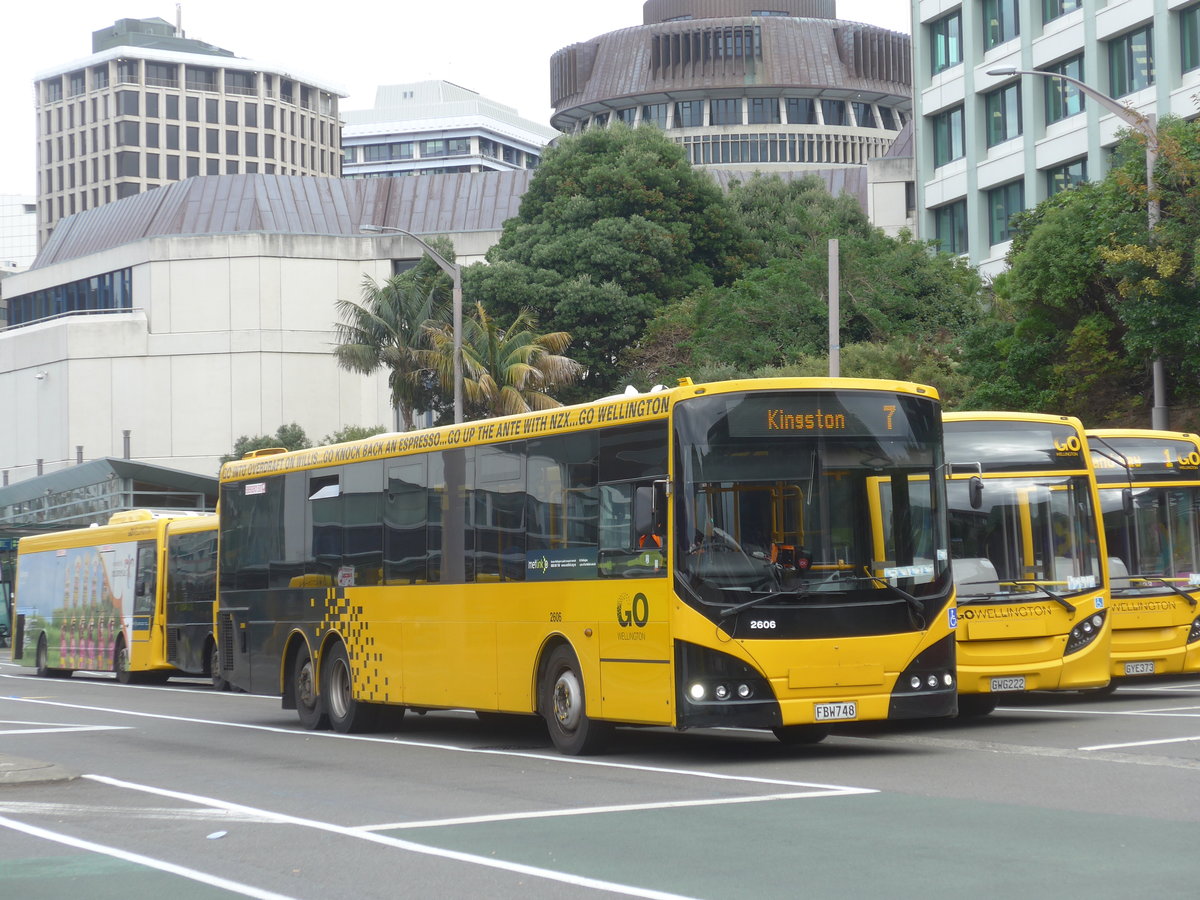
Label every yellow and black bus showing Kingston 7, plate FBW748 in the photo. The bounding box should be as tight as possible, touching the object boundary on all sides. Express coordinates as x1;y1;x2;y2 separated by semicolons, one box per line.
217;379;956;754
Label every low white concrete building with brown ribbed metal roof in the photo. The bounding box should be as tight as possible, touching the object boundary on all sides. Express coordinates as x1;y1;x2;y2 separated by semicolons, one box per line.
0;170;532;482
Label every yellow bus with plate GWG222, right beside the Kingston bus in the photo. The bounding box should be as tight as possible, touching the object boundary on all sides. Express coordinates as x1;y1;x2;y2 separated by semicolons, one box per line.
942;413;1112;715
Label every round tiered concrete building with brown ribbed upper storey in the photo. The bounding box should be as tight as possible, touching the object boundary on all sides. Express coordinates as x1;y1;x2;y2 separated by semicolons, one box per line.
550;0;912;170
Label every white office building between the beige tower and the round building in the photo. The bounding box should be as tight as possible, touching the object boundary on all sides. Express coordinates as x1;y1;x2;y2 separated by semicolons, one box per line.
342;82;558;178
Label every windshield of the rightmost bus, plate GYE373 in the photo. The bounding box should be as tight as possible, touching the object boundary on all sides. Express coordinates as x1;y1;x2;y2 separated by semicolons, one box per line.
1100;485;1200;593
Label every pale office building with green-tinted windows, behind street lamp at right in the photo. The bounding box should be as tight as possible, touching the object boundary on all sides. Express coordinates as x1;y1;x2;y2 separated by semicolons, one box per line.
913;0;1200;275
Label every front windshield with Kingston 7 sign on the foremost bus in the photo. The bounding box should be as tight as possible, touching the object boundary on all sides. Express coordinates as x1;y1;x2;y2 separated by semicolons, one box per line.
674;390;948;610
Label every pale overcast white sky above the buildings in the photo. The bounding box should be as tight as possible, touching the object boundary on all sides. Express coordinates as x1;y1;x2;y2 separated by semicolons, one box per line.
0;0;911;197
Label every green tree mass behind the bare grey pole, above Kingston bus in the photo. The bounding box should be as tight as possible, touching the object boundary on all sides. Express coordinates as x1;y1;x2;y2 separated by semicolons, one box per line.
623;176;982;384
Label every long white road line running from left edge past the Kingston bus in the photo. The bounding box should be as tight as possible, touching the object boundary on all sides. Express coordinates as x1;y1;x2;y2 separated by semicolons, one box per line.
0;697;876;794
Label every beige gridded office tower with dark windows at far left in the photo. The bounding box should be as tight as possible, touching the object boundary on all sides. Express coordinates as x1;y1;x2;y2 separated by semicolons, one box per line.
35;19;346;245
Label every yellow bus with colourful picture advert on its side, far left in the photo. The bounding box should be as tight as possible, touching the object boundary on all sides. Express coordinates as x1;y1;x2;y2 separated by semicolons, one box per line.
13;509;222;686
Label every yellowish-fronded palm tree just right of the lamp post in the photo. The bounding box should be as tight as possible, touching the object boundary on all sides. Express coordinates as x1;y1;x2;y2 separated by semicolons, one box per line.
430;304;583;416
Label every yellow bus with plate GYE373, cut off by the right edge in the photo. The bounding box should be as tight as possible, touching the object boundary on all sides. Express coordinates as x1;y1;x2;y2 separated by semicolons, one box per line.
1087;428;1200;679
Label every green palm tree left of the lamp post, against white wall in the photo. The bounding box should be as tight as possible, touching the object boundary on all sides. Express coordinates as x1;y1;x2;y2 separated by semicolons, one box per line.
334;275;448;431
